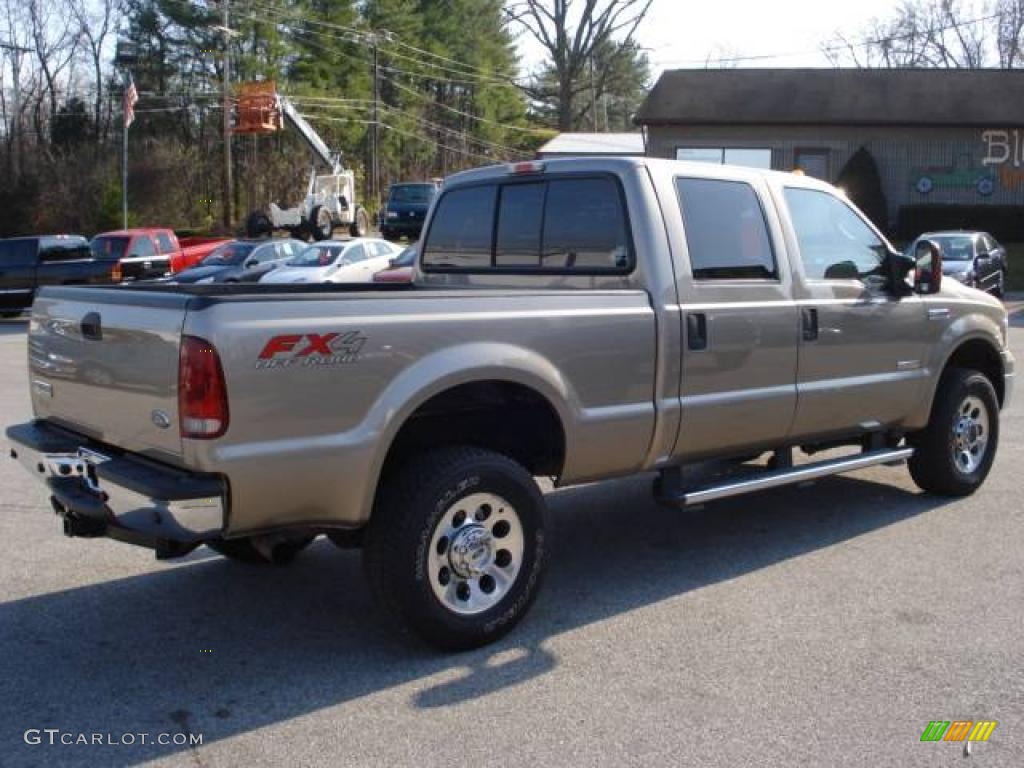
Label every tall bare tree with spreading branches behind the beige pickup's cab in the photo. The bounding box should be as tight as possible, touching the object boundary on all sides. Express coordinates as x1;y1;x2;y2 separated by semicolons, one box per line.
506;0;652;131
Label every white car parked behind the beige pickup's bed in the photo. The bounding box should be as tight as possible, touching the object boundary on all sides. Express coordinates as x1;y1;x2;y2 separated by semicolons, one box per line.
260;238;400;283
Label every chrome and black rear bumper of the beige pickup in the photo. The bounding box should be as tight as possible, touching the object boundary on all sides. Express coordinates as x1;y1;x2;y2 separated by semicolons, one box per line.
7;421;227;552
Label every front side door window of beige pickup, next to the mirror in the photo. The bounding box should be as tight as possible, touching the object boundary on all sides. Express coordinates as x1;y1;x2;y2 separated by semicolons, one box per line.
785;187;888;280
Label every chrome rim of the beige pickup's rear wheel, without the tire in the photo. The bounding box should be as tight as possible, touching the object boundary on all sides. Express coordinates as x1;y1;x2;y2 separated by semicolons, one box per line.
427;494;525;615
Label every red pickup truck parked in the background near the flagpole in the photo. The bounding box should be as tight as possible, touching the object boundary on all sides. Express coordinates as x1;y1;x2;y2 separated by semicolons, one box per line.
89;227;227;280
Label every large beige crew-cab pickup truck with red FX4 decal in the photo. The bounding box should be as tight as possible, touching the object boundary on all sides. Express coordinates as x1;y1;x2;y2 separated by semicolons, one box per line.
7;159;1014;648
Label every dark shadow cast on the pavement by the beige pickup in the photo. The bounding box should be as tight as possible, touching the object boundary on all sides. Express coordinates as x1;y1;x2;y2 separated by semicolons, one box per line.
0;476;946;765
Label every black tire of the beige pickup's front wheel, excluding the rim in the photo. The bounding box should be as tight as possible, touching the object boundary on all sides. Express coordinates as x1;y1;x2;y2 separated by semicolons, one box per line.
907;368;999;496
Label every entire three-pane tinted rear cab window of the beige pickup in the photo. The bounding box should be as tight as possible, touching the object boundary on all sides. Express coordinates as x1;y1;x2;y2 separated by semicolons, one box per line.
423;174;635;274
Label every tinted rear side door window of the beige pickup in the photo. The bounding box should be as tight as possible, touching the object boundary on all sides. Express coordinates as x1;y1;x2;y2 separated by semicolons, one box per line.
676;178;778;280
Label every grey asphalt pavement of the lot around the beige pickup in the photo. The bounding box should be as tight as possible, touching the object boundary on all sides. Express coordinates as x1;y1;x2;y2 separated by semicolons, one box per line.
0;304;1024;768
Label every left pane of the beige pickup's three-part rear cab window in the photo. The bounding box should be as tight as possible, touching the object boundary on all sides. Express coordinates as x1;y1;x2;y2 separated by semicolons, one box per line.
423;184;498;269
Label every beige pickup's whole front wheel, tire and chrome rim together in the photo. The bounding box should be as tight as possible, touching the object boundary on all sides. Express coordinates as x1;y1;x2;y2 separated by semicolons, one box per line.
908;368;999;496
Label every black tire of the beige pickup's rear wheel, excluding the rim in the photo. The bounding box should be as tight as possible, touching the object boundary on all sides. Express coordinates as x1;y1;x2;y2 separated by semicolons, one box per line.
362;446;548;650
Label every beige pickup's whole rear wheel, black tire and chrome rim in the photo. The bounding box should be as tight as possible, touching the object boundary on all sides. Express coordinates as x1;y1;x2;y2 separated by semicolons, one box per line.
362;447;546;650
